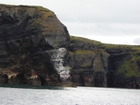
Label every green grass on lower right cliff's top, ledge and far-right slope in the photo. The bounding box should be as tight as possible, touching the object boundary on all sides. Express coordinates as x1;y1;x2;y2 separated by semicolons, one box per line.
70;36;140;77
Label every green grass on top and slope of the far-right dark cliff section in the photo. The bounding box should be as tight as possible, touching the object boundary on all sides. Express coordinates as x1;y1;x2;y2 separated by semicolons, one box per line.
104;44;140;77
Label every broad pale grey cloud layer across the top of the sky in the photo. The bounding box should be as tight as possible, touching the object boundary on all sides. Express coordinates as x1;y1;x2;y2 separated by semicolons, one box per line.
1;0;140;24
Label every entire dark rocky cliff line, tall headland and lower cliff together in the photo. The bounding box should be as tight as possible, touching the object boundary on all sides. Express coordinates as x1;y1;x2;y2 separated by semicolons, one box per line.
0;4;140;88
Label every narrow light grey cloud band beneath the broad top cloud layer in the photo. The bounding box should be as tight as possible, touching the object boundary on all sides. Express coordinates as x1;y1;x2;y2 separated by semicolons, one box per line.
64;22;140;36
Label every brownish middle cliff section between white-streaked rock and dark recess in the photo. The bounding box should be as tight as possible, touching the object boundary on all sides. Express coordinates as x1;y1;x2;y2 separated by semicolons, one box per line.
68;36;110;87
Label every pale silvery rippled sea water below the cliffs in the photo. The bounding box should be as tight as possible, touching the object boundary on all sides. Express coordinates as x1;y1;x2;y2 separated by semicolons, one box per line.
0;87;140;105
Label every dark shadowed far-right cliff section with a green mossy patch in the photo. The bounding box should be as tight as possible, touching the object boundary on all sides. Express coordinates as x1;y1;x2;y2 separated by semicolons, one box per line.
105;44;140;88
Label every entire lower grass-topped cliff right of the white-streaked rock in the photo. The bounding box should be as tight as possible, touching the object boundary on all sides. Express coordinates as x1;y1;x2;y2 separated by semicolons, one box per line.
68;36;140;88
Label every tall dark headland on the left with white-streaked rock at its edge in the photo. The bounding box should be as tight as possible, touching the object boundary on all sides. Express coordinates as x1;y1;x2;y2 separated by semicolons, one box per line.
0;5;70;85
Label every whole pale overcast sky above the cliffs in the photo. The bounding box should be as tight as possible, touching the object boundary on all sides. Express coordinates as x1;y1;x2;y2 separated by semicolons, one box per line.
0;0;140;45
